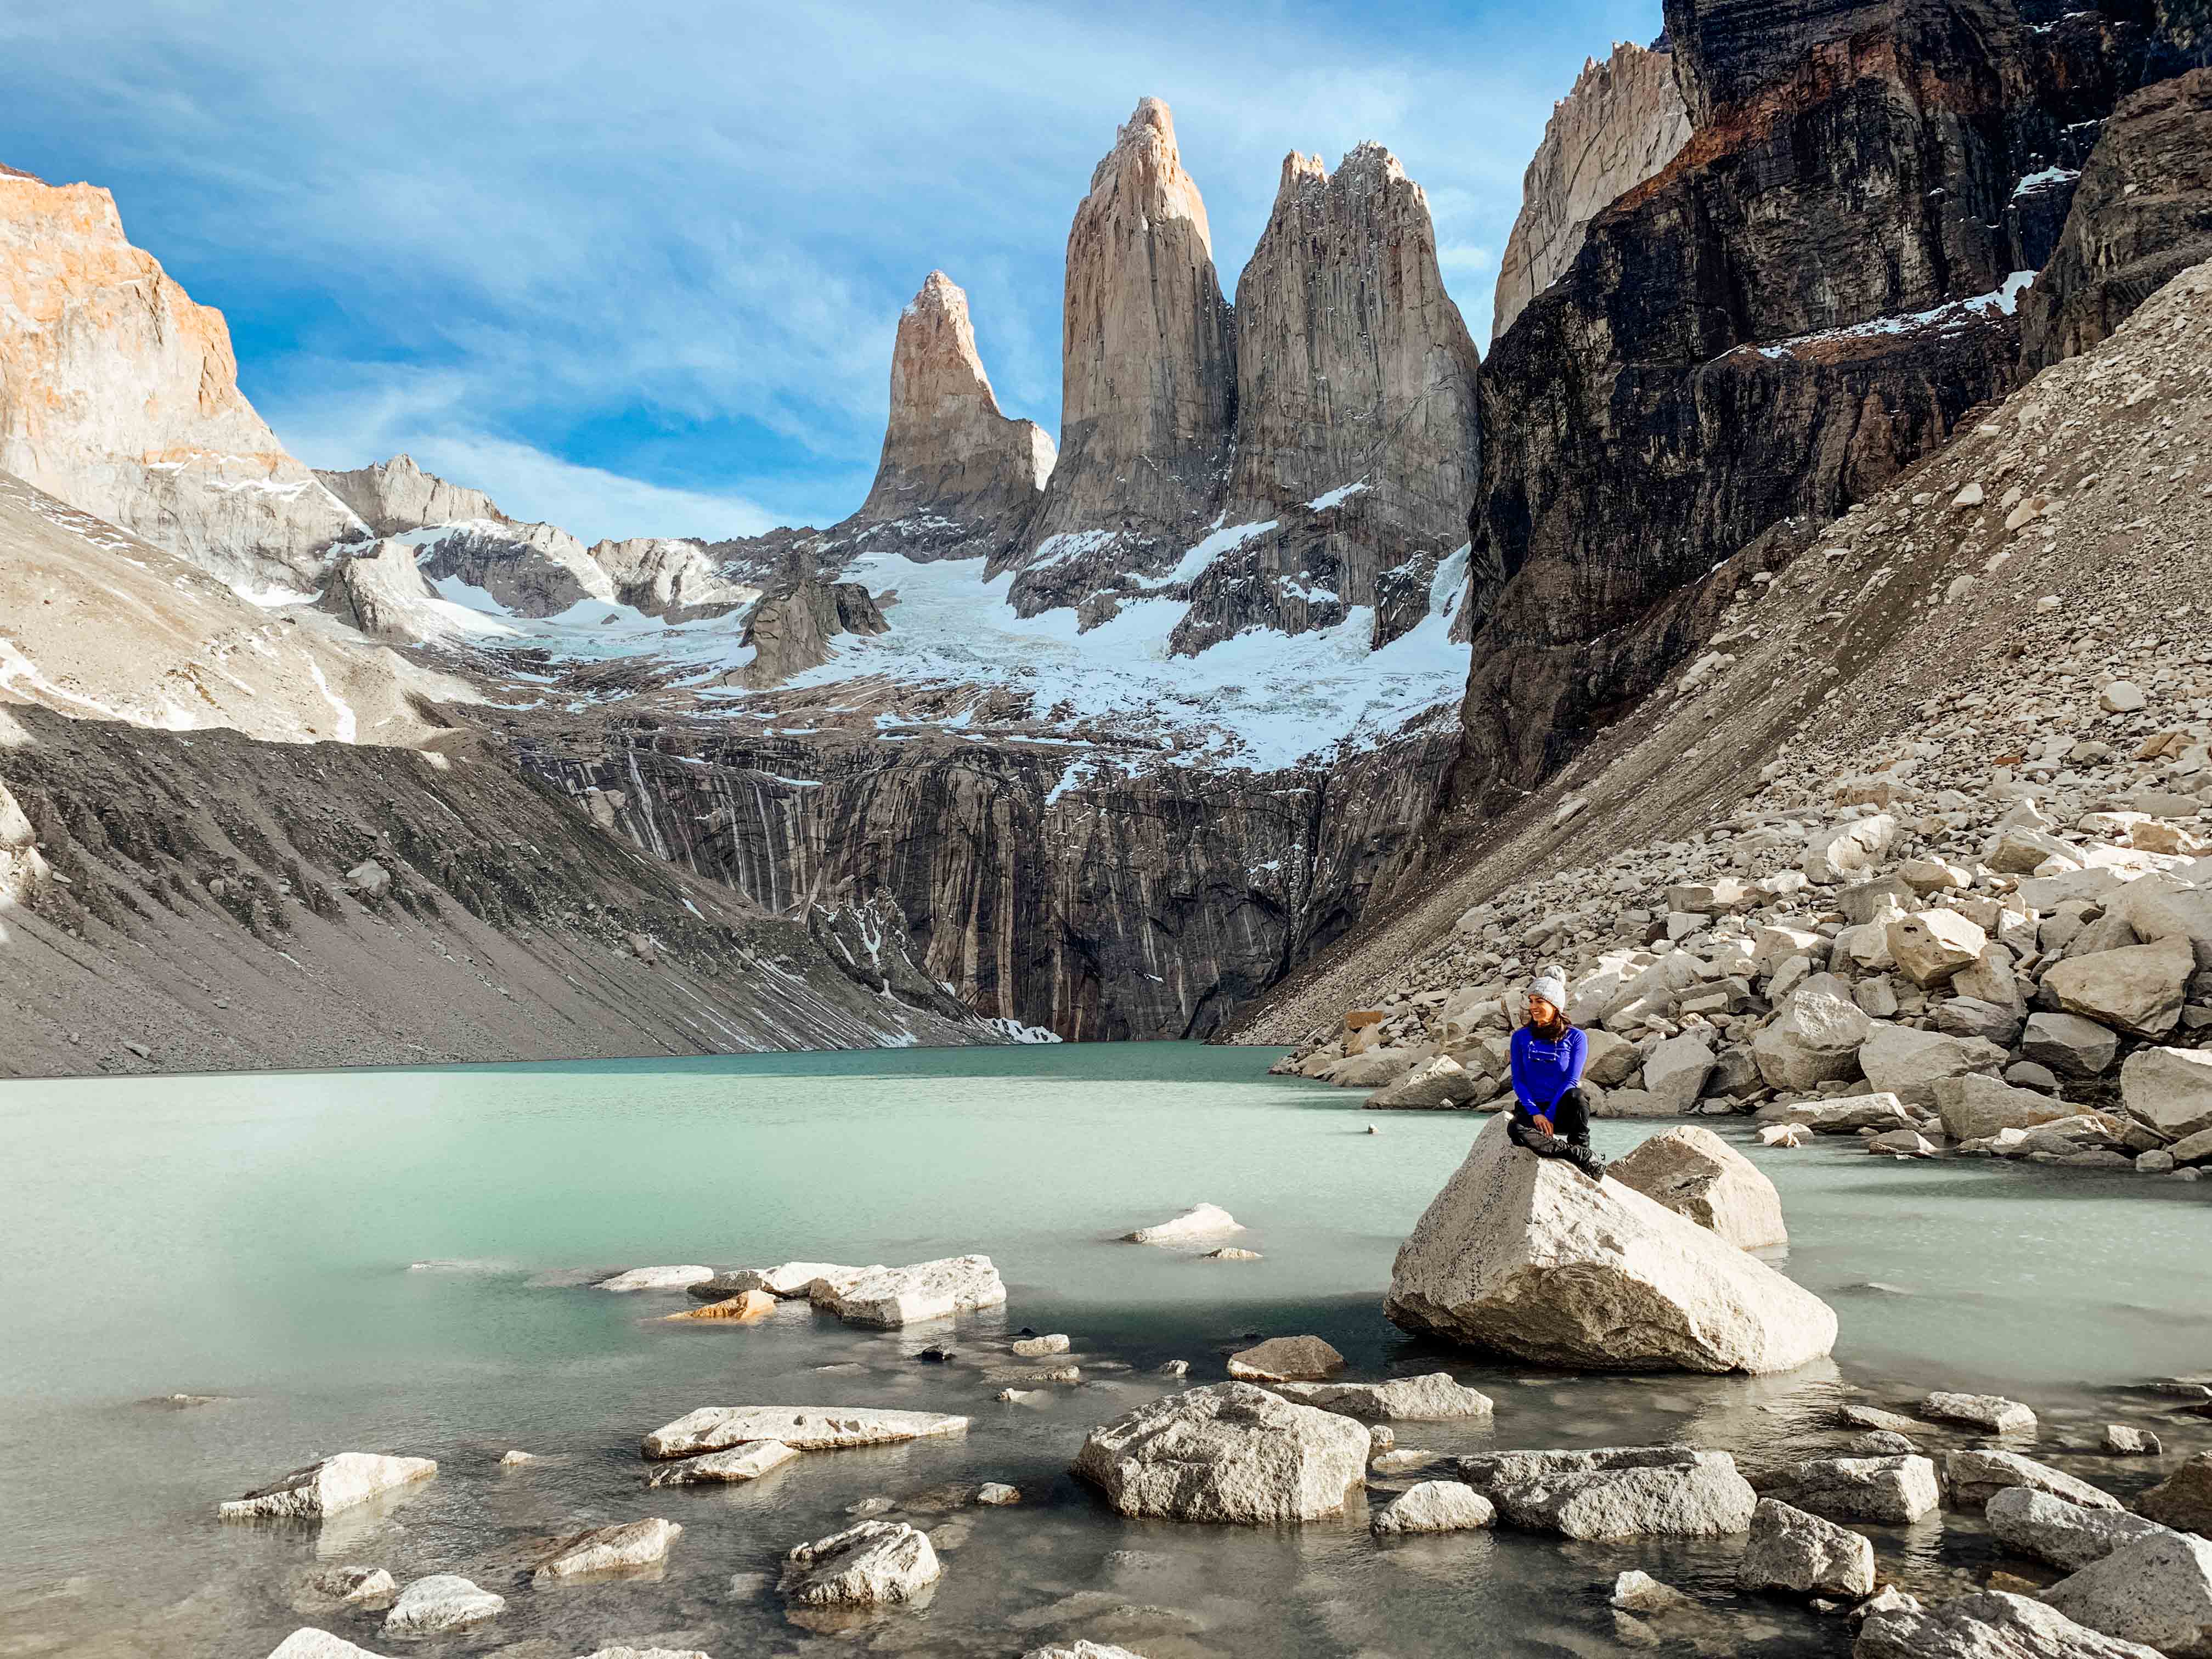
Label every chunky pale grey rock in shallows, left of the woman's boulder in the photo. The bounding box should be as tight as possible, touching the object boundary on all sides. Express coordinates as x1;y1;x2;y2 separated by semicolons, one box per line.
1073;1383;1369;1526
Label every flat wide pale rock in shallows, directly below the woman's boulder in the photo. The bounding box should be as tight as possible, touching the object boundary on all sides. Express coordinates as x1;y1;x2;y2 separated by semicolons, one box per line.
1460;1447;1758;1537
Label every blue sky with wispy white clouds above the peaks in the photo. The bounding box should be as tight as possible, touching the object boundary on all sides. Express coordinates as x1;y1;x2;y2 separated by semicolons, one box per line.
0;0;1661;538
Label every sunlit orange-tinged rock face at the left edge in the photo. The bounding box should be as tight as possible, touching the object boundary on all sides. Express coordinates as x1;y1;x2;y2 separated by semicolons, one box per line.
0;170;363;595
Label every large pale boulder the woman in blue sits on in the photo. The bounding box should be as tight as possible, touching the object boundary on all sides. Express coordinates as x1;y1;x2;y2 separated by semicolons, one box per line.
1383;1115;1836;1372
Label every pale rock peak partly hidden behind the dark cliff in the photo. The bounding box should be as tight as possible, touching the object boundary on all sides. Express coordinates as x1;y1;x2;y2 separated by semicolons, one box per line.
1491;42;1690;338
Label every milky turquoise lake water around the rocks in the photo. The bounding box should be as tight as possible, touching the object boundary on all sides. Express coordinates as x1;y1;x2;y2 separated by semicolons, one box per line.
0;1044;2212;1659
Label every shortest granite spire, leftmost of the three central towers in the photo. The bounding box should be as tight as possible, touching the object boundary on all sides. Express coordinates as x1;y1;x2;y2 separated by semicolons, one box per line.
856;270;1053;557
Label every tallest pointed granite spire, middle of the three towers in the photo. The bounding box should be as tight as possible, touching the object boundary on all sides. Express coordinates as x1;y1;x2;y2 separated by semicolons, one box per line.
1015;97;1237;611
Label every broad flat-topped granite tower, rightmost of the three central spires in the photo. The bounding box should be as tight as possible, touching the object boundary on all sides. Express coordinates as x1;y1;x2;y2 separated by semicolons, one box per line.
1148;144;1480;652
